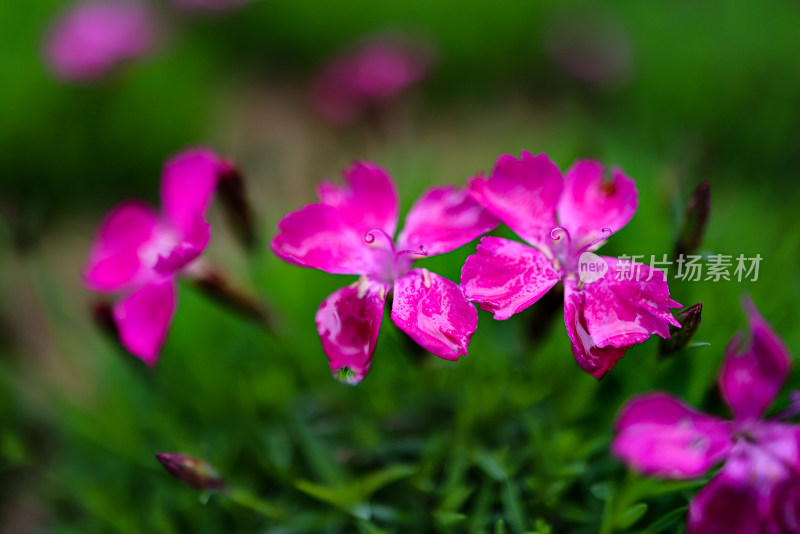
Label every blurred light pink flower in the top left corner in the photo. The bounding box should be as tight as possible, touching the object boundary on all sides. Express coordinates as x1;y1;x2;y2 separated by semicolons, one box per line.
45;0;155;81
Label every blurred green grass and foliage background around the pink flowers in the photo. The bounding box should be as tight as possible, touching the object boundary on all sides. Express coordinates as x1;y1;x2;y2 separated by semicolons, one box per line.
0;0;800;534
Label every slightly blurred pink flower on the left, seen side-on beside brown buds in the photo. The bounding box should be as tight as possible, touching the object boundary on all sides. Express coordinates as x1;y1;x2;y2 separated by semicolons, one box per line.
84;149;228;365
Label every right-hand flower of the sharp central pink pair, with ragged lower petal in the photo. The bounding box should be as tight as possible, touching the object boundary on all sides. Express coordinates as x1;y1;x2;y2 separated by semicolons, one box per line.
461;152;680;379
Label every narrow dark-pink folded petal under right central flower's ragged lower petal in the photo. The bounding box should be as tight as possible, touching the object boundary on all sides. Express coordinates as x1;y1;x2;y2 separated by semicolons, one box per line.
564;279;630;380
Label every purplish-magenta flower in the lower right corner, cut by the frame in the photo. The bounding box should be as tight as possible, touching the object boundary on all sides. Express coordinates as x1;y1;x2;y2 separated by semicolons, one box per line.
611;300;800;534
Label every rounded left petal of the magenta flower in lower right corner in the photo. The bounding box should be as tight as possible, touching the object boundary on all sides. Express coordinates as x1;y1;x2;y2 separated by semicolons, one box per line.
611;393;732;478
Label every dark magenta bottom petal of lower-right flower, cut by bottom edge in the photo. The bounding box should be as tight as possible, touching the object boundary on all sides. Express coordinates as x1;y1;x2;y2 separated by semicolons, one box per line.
687;476;764;534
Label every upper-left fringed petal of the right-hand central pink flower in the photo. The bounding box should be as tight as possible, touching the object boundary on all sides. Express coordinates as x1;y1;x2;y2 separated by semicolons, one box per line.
469;151;563;248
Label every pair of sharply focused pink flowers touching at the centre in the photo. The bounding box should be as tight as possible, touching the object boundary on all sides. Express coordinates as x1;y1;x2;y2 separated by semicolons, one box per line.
272;152;680;384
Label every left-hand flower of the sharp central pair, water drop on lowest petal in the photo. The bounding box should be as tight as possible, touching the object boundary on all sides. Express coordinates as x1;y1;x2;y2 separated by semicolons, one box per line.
272;162;497;384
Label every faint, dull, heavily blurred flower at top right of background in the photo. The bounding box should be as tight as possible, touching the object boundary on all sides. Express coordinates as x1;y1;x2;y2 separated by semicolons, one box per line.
544;8;633;86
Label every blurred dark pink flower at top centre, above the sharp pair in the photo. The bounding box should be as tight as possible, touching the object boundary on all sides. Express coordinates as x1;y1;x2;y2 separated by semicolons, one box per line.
313;36;433;124
